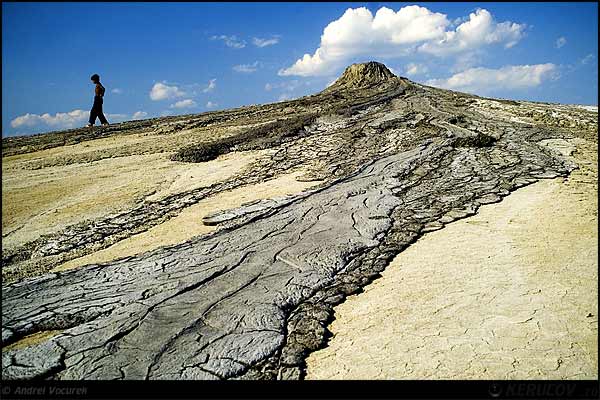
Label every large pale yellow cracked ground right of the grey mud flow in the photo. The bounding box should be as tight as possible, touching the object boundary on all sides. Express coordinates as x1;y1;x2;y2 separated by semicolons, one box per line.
307;142;598;379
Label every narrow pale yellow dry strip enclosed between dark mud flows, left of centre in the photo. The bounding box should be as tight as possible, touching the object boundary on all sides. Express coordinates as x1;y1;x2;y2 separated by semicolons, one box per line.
51;171;319;272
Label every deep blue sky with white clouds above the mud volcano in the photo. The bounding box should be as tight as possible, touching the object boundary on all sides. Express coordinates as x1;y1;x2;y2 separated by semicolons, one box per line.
2;2;598;137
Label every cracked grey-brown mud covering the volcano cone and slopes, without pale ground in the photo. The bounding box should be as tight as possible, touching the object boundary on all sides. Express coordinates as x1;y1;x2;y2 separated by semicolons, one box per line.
2;64;597;379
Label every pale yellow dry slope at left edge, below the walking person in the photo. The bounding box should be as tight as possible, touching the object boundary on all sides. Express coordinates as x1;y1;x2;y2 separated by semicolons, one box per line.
2;135;265;249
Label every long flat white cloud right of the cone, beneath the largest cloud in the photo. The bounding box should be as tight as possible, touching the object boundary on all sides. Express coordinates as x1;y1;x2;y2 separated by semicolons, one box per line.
426;63;558;94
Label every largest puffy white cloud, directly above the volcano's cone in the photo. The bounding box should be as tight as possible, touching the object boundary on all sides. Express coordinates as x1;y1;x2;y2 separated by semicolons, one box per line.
279;5;525;76
